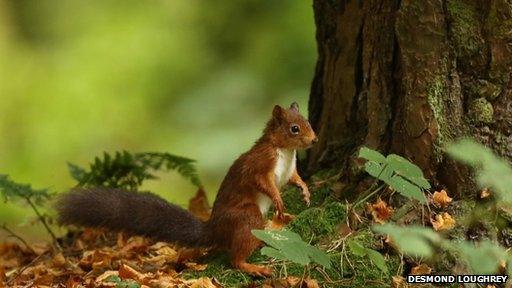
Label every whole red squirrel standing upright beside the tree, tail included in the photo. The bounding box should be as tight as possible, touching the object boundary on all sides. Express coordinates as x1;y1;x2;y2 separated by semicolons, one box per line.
56;102;318;276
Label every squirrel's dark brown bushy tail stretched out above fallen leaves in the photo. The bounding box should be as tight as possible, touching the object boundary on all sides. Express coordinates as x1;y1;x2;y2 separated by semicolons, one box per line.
56;188;211;247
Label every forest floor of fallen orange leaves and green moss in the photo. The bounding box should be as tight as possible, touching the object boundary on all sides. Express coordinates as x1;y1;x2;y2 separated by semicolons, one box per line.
0;173;504;288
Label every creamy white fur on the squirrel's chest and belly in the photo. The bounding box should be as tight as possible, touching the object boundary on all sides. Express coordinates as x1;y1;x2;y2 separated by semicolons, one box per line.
256;149;296;215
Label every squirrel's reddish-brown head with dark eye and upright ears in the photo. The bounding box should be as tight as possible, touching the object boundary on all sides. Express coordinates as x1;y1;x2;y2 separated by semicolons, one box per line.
265;102;318;149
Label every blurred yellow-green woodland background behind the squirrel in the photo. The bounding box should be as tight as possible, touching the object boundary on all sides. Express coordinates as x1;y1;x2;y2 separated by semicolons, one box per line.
0;0;316;240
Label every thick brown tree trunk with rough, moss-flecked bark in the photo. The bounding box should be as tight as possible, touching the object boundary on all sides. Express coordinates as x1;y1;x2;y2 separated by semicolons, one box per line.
308;0;512;196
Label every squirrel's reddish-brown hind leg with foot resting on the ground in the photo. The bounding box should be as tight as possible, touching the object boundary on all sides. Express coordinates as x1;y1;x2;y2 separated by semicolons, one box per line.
229;206;273;277
